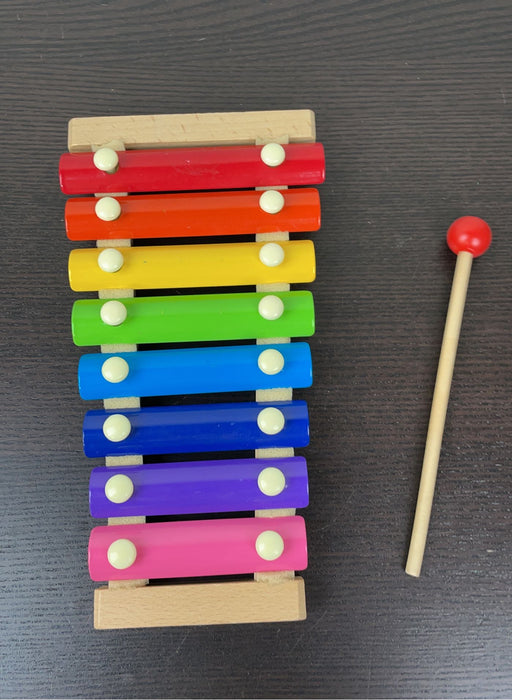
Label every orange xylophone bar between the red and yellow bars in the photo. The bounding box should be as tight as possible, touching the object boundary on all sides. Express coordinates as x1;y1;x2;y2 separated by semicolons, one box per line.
64;188;320;241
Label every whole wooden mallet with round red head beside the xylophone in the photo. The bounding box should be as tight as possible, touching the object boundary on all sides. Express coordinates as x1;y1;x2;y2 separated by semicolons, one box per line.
405;216;492;576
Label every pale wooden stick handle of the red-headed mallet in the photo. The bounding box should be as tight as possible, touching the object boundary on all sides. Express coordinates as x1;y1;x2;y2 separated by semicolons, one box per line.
405;251;473;576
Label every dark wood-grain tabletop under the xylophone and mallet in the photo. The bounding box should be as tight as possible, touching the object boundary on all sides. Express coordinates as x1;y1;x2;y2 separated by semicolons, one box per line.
0;0;512;698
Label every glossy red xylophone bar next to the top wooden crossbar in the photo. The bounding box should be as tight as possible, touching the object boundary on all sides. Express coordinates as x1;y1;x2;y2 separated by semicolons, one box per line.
59;143;325;194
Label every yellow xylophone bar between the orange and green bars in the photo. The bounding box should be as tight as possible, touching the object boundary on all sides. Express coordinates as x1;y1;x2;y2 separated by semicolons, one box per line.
68;241;315;292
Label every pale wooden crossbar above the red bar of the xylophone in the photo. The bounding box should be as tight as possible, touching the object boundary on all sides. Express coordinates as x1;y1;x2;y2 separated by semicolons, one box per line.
68;109;316;153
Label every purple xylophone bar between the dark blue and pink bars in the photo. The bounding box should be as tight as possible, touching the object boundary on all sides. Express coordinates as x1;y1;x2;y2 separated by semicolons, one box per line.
89;457;309;518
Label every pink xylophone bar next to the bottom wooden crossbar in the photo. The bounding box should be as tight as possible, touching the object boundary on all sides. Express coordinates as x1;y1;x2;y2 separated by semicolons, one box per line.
89;516;307;581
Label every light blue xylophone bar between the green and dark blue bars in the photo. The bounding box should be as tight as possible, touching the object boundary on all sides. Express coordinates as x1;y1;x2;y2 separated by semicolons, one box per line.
78;343;312;399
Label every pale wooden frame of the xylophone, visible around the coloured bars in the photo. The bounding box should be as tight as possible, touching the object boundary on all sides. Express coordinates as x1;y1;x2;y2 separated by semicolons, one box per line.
68;110;315;629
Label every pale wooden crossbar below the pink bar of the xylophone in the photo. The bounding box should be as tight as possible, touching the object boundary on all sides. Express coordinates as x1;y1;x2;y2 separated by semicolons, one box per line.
94;576;306;629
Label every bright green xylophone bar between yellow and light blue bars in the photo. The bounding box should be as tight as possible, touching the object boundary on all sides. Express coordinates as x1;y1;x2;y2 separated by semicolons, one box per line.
71;291;315;346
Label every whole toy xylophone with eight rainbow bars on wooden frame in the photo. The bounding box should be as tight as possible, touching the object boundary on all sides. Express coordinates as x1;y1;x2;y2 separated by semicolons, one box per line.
59;110;325;629
